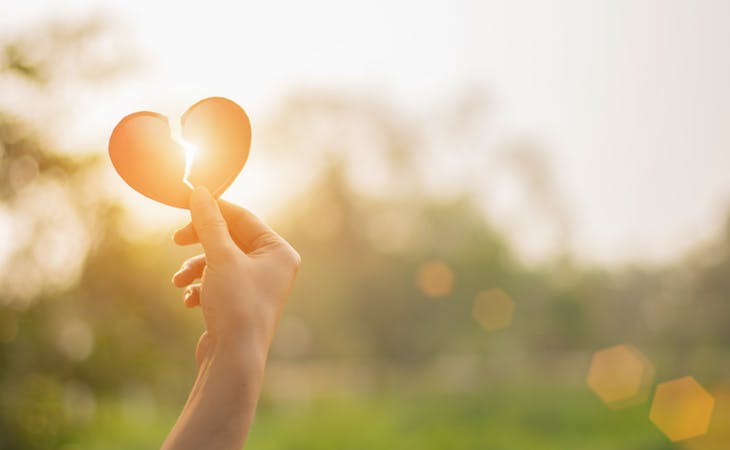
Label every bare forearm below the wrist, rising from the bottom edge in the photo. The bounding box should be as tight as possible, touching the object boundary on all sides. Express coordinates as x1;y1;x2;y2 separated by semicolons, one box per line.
162;342;265;450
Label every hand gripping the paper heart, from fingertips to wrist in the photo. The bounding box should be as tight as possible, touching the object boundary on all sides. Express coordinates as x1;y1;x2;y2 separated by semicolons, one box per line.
172;187;300;364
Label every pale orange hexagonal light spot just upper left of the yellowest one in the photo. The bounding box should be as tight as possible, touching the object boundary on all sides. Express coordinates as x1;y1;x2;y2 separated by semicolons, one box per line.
586;344;654;409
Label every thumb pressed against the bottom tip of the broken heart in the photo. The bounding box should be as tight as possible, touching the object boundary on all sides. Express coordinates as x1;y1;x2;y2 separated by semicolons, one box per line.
190;186;234;259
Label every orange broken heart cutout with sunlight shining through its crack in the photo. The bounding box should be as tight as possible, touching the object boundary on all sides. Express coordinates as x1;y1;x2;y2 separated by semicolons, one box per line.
109;97;251;208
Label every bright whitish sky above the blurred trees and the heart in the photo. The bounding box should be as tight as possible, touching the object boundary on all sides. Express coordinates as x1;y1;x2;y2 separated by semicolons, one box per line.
0;0;730;261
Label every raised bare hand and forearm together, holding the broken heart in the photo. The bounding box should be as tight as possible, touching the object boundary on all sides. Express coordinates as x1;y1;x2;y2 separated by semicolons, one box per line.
162;187;301;450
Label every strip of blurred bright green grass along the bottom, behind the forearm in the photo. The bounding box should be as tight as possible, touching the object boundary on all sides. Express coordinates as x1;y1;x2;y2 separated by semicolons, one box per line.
62;386;678;450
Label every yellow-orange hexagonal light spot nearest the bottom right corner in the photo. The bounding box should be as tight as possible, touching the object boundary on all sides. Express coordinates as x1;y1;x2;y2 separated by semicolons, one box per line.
649;377;715;442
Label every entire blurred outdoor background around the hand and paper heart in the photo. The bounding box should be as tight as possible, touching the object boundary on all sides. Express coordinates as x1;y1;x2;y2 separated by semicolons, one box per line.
0;0;730;450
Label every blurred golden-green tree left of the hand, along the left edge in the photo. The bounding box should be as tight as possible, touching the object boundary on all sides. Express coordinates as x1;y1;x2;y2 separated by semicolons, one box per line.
0;15;198;449
